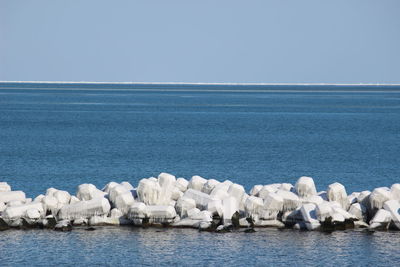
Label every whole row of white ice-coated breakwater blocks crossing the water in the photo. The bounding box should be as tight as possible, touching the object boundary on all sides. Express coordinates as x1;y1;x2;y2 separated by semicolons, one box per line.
0;173;400;231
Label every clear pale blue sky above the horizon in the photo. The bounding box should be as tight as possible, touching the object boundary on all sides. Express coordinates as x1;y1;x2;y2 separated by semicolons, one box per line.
0;0;400;83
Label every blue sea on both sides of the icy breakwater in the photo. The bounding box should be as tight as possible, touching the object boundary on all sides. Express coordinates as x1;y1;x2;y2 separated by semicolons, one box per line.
0;82;400;266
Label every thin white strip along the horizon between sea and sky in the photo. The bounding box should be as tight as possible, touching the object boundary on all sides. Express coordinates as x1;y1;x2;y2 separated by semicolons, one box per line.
0;81;400;86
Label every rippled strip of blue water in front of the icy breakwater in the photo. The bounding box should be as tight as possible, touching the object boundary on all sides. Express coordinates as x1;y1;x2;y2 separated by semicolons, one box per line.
0;227;400;266
